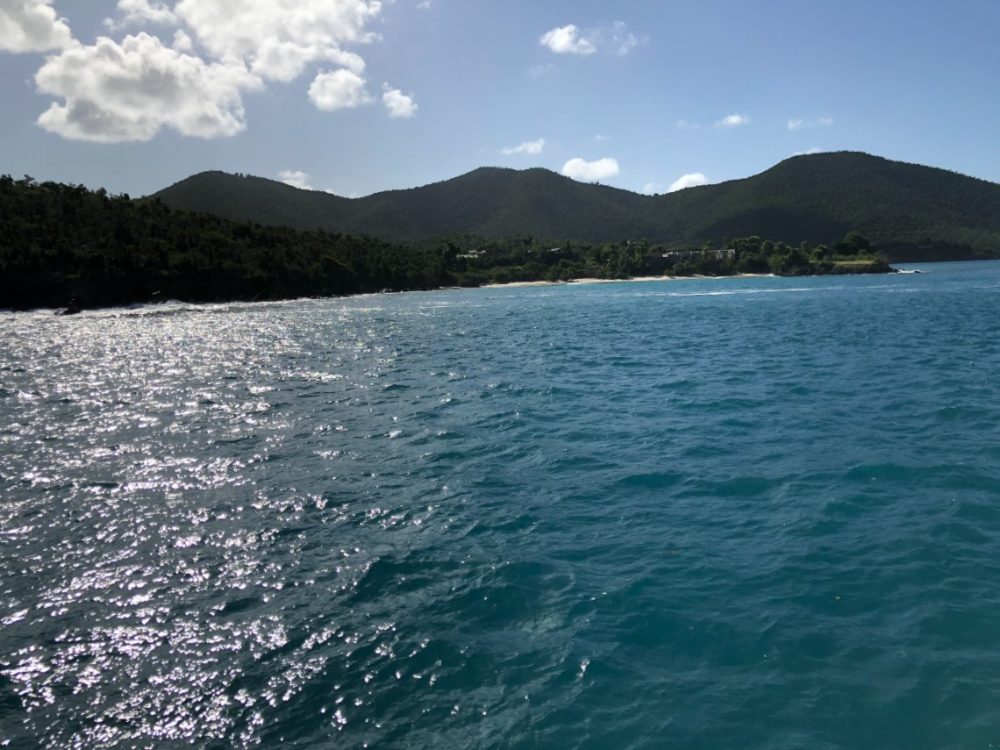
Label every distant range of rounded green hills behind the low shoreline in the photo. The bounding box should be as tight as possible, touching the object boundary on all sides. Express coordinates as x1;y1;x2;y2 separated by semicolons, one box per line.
157;152;1000;261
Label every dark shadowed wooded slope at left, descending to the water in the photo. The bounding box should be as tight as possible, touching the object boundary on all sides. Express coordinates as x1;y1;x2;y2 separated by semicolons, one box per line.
0;177;451;308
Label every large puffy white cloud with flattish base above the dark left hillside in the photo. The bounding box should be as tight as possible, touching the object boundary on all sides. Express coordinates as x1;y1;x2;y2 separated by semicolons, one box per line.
35;33;262;143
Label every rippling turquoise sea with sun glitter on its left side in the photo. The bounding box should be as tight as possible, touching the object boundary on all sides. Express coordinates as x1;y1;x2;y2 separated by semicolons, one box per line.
0;263;1000;750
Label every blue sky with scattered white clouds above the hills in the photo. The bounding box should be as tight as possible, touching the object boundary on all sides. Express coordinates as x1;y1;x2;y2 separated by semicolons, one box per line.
0;0;1000;196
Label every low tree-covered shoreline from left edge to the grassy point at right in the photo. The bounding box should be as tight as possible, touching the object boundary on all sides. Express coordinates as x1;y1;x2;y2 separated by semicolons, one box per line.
0;176;889;309
